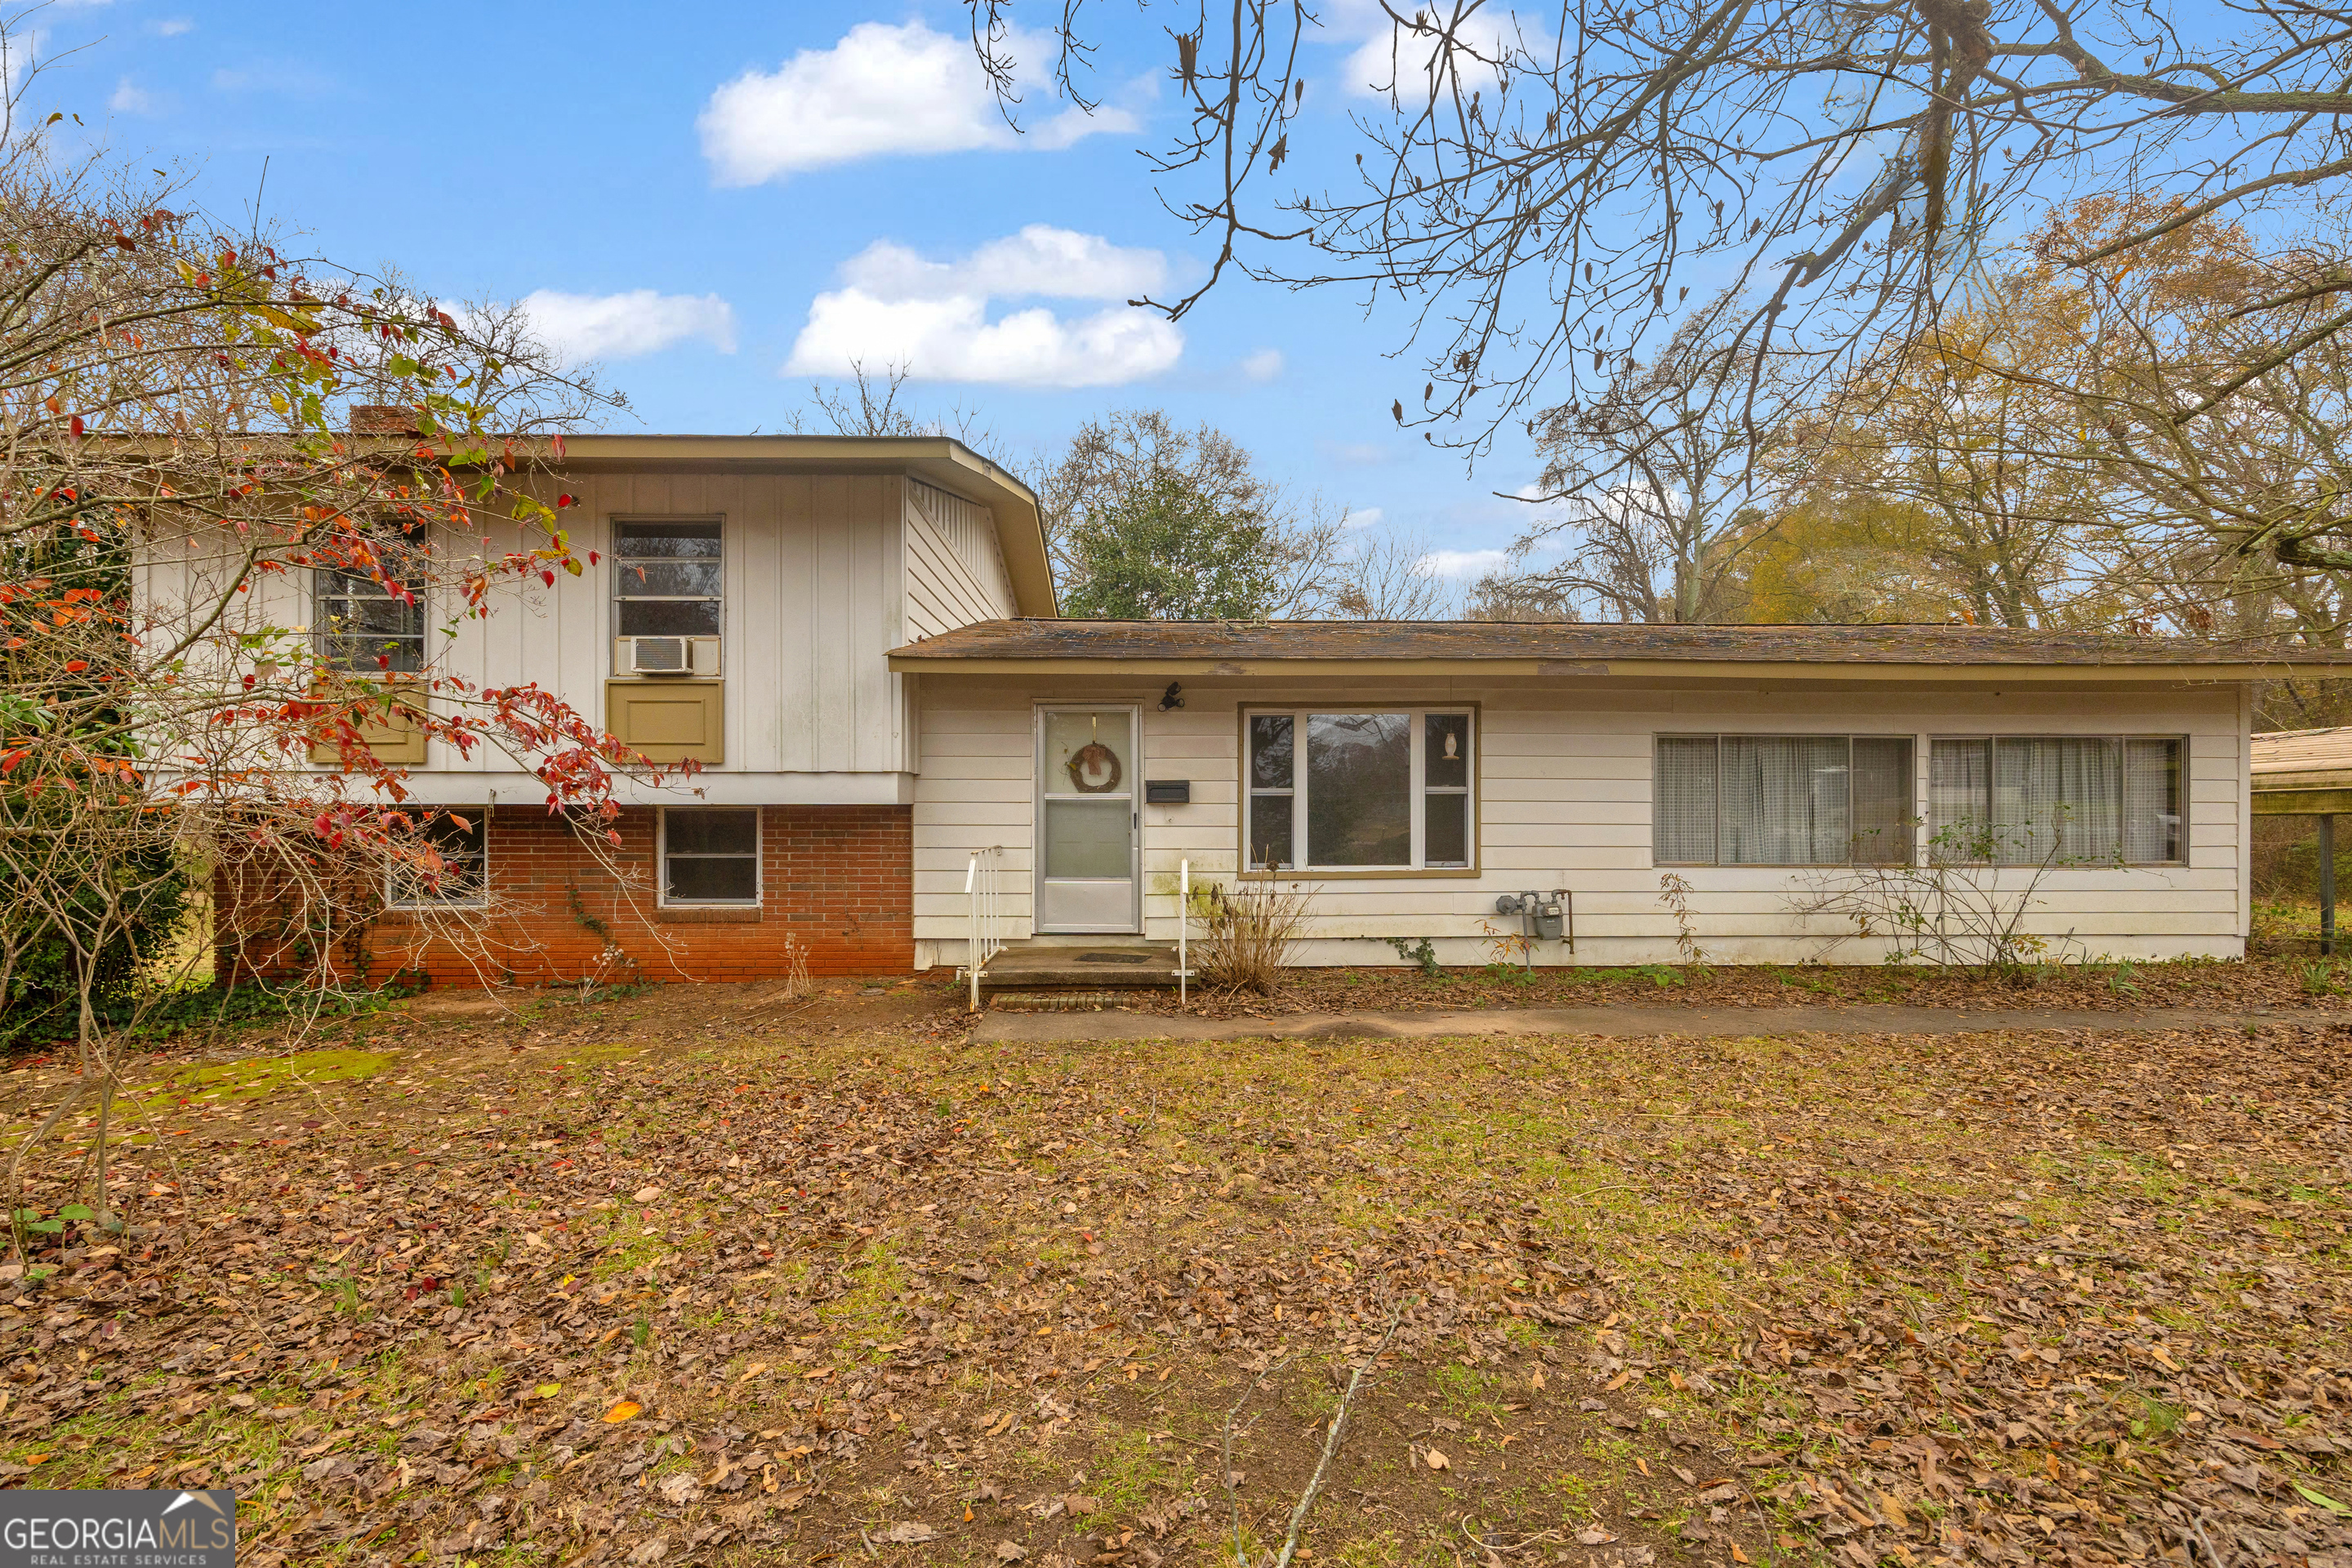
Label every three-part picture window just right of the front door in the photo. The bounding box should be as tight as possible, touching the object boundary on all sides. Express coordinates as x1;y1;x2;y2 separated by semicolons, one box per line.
1242;707;1477;872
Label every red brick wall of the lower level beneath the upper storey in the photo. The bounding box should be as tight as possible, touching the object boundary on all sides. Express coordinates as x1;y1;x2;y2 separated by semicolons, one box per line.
216;806;915;987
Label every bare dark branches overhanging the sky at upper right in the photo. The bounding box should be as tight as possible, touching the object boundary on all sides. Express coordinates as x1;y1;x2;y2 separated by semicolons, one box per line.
967;0;2352;447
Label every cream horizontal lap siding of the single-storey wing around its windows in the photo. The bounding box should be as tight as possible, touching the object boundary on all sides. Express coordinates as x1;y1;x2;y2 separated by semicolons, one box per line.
915;677;2246;964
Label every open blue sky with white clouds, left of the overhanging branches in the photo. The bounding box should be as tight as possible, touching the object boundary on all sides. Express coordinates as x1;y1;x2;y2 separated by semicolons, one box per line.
33;0;1534;587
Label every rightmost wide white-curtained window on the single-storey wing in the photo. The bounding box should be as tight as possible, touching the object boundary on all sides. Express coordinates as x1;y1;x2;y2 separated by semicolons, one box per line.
1929;736;2187;865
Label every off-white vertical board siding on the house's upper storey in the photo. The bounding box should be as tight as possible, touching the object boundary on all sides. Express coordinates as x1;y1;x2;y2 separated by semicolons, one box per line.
141;468;1016;804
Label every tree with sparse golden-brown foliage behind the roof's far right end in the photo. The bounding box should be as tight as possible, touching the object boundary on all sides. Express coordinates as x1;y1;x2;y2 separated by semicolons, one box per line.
1813;198;2352;625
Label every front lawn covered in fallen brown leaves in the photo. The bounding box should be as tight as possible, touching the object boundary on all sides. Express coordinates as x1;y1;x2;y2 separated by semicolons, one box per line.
0;987;2352;1566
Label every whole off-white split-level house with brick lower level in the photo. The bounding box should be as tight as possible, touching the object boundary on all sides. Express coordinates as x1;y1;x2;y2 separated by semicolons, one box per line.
156;435;2342;978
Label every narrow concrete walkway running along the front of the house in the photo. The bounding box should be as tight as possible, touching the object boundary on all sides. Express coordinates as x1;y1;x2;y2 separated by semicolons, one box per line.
973;1006;2352;1041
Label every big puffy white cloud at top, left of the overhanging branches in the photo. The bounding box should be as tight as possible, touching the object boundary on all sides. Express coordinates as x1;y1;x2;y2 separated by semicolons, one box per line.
696;21;1138;185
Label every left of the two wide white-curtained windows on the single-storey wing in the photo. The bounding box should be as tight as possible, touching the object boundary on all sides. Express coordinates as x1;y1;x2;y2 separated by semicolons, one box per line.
1651;736;1917;865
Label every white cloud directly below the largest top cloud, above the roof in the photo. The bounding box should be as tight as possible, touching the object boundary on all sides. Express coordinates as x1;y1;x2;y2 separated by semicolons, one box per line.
783;223;1183;385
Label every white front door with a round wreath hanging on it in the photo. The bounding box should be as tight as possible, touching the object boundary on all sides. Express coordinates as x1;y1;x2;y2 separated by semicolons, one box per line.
1037;707;1143;931
